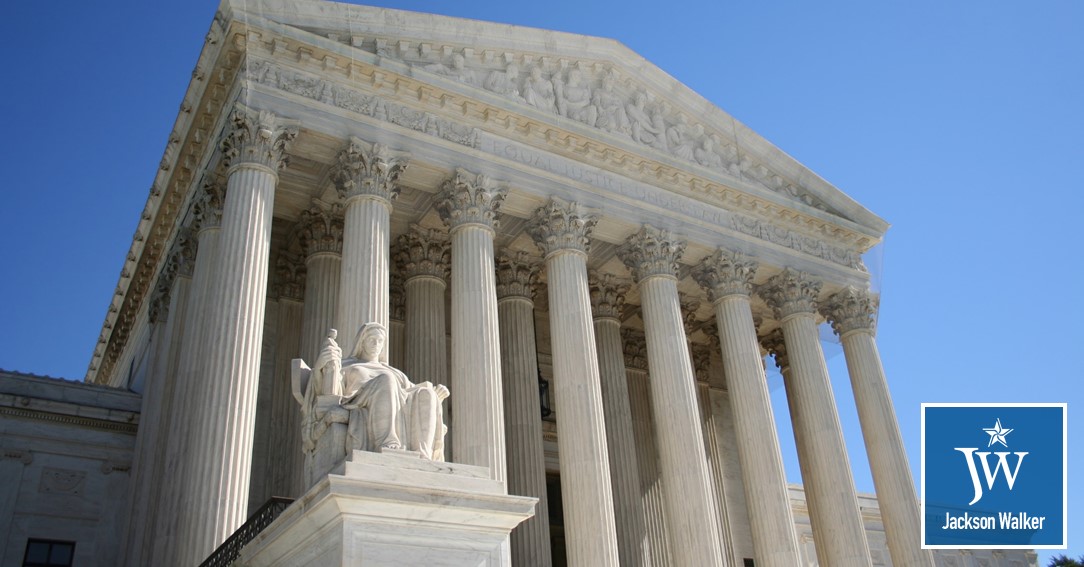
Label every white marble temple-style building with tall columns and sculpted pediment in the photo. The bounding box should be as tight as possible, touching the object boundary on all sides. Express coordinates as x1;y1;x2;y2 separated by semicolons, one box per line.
0;0;1023;567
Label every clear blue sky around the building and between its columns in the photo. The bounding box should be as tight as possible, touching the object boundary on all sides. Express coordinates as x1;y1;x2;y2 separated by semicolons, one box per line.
0;0;1084;564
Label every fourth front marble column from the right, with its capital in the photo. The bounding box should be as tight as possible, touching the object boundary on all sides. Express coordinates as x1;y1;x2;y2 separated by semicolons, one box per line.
618;225;726;565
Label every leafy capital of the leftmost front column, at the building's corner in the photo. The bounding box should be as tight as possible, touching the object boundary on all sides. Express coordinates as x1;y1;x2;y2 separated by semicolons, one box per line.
222;104;297;171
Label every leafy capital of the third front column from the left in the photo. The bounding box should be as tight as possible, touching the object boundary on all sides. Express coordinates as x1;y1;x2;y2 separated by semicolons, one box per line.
436;169;508;231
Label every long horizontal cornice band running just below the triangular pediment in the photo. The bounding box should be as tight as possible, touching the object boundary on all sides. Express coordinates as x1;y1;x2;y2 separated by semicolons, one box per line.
237;22;880;252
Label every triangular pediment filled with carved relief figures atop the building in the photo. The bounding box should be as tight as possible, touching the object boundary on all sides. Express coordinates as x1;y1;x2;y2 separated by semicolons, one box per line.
223;0;888;236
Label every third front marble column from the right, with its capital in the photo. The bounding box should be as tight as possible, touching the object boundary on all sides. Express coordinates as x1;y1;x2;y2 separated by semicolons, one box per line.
694;249;800;567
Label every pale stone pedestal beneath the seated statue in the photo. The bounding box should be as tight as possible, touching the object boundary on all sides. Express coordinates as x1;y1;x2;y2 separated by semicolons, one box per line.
238;451;537;567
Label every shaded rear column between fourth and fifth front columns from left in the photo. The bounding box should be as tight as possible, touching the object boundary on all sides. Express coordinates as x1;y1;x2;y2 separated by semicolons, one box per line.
590;273;650;565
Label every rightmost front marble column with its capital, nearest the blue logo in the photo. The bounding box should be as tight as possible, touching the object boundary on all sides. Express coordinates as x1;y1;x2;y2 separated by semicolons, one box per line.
822;286;933;567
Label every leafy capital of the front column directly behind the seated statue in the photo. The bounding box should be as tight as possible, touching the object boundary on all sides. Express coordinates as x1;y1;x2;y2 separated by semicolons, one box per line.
331;137;408;202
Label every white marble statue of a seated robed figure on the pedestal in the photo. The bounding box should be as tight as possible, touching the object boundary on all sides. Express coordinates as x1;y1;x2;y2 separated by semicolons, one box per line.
292;323;449;487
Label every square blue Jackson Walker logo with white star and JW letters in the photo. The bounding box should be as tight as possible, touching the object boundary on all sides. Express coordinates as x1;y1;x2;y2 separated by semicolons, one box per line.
921;403;1068;550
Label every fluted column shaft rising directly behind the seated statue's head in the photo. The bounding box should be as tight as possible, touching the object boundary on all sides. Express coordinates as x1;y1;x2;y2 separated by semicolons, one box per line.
338;195;391;348
